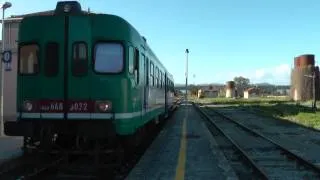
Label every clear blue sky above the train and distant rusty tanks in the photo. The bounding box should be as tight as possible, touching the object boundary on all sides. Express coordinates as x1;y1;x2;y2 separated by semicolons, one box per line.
2;0;320;85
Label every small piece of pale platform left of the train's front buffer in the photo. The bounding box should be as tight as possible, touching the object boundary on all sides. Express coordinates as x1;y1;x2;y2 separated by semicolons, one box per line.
0;136;23;164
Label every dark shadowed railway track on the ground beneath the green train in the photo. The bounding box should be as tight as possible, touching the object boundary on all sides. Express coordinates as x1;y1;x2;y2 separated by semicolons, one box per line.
0;144;147;180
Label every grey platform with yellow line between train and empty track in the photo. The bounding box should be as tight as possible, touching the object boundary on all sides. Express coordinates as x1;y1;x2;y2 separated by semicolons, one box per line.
126;103;238;180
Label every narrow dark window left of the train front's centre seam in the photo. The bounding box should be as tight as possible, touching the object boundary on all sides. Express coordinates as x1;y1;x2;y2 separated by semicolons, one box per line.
44;43;59;77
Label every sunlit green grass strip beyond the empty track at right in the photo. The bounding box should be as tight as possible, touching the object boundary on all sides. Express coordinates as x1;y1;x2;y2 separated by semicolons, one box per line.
189;97;320;129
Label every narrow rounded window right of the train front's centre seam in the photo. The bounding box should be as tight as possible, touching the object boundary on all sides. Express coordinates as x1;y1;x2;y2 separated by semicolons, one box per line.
72;42;88;76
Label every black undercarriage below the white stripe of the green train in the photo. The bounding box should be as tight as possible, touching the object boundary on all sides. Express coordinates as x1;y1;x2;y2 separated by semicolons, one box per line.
5;116;163;159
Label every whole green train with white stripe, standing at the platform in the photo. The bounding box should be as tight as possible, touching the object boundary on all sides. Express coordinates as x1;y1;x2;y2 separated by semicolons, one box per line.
5;1;175;151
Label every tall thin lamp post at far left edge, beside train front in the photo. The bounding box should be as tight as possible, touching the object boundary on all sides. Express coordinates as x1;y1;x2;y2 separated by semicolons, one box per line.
0;2;12;136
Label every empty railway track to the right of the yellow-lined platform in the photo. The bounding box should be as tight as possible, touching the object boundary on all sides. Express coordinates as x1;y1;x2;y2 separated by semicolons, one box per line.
194;104;320;179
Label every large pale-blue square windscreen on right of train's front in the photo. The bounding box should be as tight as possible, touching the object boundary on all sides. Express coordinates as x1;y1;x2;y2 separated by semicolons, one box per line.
94;43;124;73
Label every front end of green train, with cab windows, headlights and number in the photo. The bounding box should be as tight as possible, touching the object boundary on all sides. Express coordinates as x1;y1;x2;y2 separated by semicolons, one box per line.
5;1;130;148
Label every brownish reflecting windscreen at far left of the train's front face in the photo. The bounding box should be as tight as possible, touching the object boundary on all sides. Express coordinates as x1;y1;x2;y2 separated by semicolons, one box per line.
19;44;39;74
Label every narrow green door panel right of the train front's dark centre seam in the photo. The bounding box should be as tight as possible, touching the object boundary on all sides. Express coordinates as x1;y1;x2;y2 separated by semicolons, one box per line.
64;16;92;116
